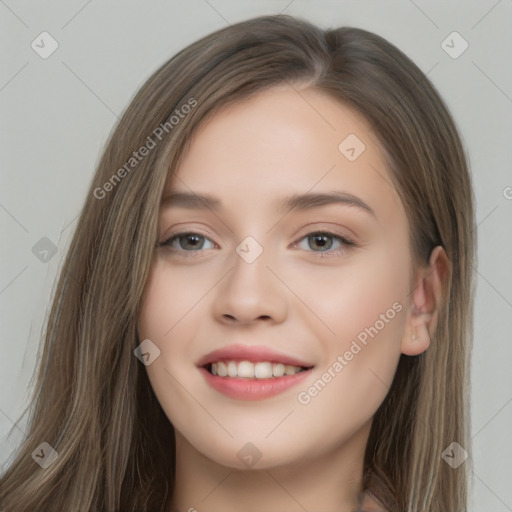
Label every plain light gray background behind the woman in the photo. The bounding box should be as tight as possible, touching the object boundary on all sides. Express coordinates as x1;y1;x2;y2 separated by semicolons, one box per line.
0;0;512;512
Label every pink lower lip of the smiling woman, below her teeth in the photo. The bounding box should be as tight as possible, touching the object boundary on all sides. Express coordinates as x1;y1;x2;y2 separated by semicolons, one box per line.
199;368;311;400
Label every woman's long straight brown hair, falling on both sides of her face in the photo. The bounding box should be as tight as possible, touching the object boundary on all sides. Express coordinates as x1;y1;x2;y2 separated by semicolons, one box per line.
0;15;476;512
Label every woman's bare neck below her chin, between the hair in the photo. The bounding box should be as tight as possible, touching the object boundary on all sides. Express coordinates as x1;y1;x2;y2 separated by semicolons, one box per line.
171;423;371;512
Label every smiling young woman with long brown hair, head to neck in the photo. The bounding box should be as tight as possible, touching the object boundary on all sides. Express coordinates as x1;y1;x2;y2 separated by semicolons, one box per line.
0;15;475;512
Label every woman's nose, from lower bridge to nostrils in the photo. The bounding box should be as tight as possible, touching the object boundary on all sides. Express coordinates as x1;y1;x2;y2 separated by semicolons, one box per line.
213;242;289;324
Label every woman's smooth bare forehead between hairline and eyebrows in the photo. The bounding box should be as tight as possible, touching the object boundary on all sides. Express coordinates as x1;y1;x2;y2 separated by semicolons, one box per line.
164;85;405;224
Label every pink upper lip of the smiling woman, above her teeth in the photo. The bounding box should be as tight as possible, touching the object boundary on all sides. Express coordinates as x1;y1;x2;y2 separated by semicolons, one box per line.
197;345;314;368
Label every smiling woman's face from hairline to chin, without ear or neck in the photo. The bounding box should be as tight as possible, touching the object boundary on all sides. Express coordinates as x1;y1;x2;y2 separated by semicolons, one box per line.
138;86;418;468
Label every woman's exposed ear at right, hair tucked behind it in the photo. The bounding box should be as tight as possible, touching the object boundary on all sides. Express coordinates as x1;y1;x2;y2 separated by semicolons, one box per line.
401;245;449;356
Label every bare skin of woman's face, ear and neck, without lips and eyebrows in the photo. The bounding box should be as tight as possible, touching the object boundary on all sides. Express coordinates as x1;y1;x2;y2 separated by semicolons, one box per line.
139;86;446;512
